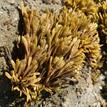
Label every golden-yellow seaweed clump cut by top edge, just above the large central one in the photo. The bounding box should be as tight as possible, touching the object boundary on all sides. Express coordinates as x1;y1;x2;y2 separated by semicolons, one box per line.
64;0;98;21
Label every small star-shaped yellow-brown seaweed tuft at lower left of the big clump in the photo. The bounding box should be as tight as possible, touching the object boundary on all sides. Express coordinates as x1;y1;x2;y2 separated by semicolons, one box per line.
5;57;41;102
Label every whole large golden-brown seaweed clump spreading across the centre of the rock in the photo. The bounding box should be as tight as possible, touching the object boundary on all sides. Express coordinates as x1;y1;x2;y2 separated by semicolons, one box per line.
5;1;101;106
